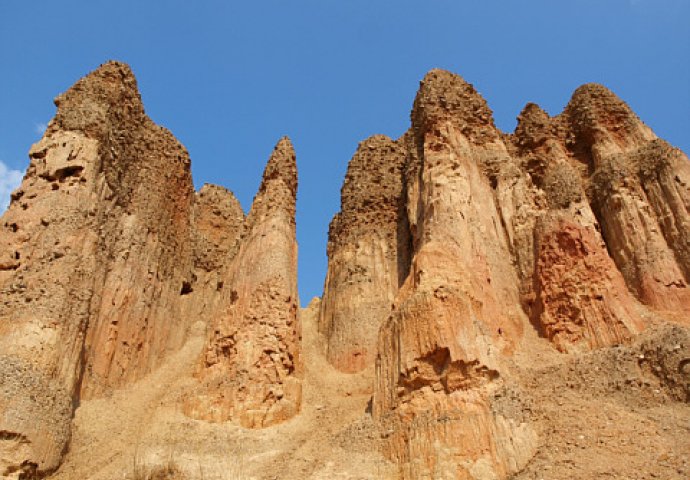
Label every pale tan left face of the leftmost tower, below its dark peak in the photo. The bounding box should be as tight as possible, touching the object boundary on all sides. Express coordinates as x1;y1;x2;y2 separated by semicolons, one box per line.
0;128;99;475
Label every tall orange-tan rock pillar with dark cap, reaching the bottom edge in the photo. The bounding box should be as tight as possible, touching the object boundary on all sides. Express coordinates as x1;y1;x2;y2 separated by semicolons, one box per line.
374;70;536;479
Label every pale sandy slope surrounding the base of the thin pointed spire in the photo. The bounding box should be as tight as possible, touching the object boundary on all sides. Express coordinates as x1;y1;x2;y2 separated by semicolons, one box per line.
51;298;394;480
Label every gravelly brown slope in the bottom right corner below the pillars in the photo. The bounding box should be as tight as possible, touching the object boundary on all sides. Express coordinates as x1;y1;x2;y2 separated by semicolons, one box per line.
514;325;690;480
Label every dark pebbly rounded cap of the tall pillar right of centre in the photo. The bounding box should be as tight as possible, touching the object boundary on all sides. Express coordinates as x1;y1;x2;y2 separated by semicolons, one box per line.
411;69;498;143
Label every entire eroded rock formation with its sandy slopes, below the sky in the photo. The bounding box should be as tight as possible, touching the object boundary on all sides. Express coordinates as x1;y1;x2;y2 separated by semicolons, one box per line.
0;62;690;480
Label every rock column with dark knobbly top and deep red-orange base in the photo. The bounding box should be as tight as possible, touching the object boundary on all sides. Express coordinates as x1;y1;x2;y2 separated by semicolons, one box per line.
513;101;644;351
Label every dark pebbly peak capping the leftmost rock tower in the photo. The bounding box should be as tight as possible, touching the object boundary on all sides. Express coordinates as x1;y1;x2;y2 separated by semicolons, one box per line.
51;61;145;137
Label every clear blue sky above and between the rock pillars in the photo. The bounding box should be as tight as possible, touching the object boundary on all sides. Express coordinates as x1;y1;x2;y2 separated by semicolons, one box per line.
0;0;690;303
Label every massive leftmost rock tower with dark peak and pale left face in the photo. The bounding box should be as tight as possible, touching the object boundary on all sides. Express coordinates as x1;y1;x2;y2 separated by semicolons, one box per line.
0;62;193;475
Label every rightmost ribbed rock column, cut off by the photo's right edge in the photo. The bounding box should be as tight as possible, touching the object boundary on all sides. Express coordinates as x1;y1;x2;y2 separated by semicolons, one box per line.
562;84;690;313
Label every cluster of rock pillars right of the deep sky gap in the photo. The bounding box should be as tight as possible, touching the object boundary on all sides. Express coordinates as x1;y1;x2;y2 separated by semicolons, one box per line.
321;70;690;478
